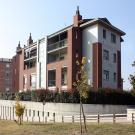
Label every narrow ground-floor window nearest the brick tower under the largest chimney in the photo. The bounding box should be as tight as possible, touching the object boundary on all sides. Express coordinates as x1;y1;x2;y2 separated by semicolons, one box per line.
61;67;67;86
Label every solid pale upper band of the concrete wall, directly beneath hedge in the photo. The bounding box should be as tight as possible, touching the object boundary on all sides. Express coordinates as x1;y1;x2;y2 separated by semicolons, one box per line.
0;100;129;115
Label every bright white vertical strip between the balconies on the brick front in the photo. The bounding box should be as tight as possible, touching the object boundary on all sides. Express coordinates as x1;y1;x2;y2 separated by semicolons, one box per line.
37;37;47;89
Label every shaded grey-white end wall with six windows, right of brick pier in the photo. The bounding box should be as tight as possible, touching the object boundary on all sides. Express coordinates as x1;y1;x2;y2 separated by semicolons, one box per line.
98;25;121;88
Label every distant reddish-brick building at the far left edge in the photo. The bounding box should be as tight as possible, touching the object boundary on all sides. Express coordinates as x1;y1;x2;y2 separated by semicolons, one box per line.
0;58;12;92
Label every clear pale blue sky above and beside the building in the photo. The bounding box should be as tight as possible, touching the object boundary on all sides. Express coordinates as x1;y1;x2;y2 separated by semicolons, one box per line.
0;0;135;90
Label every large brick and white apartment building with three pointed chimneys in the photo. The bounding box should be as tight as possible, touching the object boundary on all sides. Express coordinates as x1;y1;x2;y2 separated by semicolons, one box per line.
12;8;125;91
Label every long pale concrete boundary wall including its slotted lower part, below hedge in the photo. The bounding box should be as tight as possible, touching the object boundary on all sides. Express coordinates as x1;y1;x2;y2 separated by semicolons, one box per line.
0;100;133;122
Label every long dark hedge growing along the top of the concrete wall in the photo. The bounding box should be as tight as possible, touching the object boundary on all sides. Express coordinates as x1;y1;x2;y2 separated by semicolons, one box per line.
0;89;135;105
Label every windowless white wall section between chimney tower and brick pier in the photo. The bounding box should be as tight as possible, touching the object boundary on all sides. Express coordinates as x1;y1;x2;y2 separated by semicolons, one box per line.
82;25;98;84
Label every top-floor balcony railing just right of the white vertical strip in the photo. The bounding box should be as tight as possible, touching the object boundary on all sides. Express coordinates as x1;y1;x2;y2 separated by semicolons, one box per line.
47;39;67;52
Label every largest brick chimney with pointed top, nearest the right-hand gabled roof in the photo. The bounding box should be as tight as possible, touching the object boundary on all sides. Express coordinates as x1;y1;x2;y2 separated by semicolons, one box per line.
73;6;82;27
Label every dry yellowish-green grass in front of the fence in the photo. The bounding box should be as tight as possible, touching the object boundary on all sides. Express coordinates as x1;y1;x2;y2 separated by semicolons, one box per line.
0;120;135;135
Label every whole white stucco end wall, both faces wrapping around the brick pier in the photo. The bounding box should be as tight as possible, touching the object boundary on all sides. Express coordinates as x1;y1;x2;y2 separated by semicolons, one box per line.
82;25;121;88
